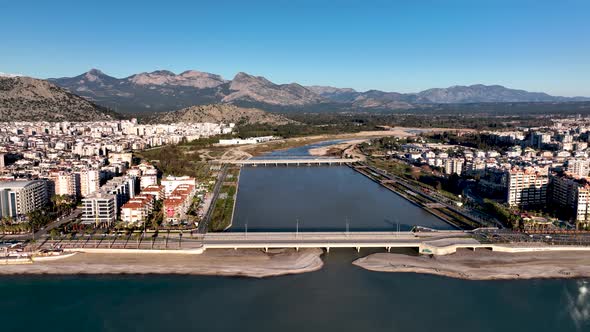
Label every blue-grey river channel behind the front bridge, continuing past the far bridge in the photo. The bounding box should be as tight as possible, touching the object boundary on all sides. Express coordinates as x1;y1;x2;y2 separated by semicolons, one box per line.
228;142;455;232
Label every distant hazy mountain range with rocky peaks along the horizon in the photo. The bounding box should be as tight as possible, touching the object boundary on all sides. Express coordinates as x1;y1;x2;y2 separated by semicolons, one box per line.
49;69;590;113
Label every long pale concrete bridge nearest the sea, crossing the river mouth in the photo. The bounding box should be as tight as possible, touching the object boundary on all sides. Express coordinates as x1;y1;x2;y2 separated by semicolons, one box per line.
203;231;490;254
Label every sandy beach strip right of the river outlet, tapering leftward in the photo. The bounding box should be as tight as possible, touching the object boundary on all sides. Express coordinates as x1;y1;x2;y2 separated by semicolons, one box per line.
353;249;590;280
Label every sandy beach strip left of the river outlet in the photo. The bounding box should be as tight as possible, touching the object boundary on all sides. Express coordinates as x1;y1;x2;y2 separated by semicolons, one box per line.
0;249;323;278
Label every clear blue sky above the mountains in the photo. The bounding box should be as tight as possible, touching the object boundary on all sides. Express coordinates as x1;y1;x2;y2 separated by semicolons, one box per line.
0;0;590;96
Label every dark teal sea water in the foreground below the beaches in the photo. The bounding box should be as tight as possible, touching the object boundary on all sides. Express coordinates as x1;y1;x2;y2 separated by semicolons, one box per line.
0;249;590;332
